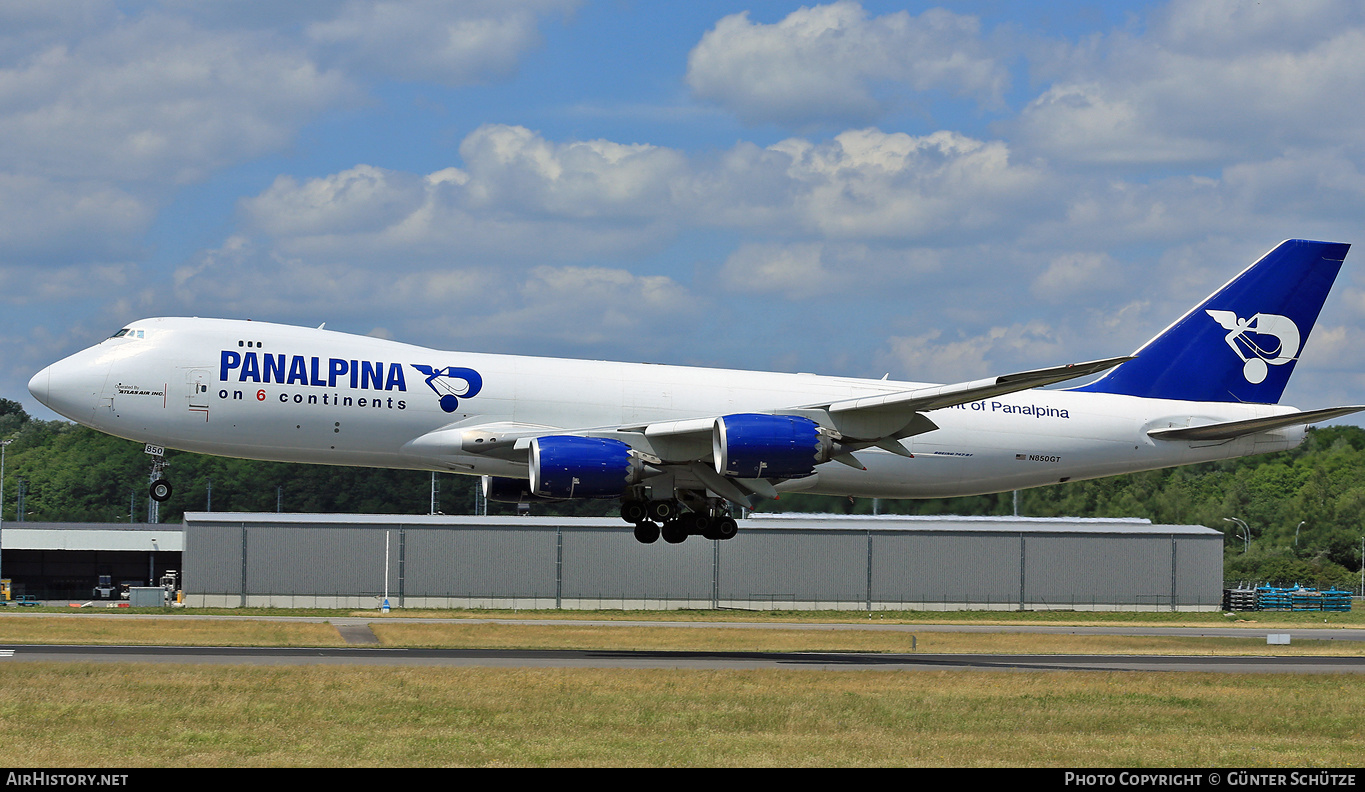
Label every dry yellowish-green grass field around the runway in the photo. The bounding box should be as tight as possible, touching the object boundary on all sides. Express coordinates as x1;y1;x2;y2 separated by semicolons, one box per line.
0;610;1365;767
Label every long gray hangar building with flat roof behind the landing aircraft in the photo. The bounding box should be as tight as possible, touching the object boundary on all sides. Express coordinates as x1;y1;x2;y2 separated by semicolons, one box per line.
183;512;1223;610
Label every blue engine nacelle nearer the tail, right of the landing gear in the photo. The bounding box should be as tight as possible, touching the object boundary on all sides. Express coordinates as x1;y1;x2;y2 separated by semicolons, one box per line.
711;412;833;478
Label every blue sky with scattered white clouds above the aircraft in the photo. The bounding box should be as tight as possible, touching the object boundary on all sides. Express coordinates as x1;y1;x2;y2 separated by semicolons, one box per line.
0;0;1365;418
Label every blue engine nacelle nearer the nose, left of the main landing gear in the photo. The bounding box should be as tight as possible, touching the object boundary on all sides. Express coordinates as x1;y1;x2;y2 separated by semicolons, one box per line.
530;434;647;498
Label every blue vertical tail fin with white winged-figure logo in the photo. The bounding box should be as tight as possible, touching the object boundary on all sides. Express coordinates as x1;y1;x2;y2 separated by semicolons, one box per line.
1076;239;1350;404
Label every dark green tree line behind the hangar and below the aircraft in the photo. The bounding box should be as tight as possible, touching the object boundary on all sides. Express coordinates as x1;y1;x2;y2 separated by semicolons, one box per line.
0;399;1365;589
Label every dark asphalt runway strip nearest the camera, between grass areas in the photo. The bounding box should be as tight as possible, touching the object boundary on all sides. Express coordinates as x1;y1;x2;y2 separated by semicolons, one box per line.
0;645;1365;673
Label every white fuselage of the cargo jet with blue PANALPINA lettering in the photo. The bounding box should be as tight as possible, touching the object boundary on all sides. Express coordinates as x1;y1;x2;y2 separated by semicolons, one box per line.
30;318;1304;498
